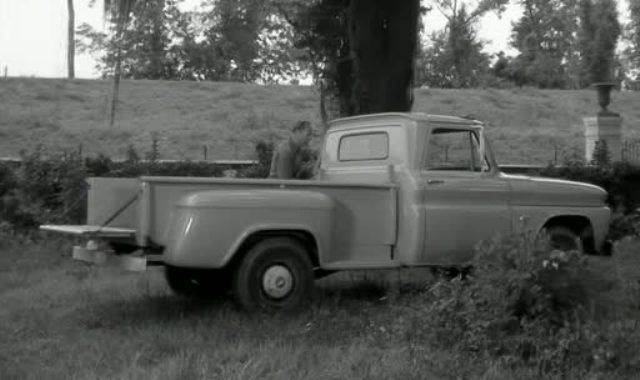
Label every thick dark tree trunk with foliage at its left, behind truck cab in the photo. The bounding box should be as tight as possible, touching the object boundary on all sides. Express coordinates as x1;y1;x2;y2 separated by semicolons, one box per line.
279;0;421;115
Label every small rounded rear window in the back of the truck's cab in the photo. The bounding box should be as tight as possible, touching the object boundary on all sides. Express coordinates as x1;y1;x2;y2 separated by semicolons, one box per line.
338;132;389;161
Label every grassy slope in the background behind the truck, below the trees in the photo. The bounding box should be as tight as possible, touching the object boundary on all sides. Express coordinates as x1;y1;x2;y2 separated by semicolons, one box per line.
0;78;640;164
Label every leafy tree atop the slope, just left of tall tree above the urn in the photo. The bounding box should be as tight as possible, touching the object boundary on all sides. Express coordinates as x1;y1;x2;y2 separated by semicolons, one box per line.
511;0;578;88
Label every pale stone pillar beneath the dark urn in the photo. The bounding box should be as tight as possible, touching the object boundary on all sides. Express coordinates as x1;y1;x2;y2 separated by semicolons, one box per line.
582;115;622;162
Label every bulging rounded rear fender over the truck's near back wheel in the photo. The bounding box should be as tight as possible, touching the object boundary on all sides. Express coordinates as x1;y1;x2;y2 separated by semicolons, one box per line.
164;189;334;268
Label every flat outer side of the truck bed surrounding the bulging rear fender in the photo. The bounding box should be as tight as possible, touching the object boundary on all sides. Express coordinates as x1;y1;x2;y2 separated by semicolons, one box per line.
138;177;397;265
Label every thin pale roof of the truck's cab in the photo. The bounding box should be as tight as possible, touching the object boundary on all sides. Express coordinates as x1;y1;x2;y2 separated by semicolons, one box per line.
329;112;482;130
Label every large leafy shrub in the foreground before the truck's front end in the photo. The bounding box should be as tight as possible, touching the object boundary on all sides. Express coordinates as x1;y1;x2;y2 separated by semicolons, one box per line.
425;236;640;376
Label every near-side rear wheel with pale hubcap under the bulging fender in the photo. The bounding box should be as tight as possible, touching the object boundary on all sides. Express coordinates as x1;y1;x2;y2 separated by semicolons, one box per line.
232;238;313;313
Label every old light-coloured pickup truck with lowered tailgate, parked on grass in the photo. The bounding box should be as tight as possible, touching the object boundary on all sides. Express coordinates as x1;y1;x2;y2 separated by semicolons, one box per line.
41;113;610;311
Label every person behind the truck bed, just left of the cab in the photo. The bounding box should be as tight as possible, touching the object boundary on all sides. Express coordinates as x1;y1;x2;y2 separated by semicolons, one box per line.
269;121;311;179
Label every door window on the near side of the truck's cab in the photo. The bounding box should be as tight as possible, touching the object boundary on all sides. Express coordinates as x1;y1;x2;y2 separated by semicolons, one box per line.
425;128;482;172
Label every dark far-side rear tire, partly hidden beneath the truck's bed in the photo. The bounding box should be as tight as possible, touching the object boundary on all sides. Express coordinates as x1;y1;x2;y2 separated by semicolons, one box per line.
164;266;231;298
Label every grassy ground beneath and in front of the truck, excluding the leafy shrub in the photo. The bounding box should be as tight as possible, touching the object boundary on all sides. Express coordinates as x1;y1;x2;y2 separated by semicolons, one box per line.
0;235;640;380
